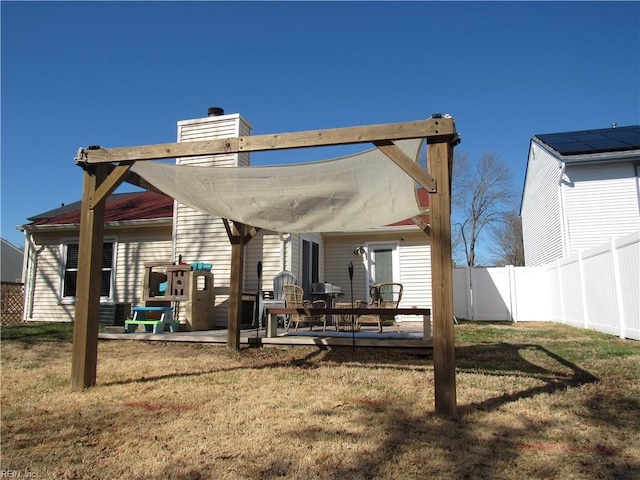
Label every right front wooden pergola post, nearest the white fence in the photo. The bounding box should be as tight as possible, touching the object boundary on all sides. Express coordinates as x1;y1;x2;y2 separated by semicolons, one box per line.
427;140;456;416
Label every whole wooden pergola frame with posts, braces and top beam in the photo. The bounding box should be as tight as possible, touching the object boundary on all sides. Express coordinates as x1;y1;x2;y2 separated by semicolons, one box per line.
71;115;459;416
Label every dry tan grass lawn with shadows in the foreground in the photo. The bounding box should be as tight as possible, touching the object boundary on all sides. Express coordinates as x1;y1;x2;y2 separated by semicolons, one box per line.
1;323;640;479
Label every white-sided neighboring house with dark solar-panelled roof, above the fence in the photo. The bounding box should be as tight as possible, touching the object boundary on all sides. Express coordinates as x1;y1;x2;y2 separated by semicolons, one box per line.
520;125;640;266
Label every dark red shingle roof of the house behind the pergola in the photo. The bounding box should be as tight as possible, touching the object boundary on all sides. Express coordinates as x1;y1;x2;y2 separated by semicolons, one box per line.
29;191;173;225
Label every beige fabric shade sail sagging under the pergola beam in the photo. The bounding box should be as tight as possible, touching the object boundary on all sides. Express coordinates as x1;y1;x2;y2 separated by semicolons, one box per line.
132;139;425;233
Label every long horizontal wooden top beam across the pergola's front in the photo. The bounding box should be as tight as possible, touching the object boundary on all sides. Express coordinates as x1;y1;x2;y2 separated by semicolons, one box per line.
76;118;455;165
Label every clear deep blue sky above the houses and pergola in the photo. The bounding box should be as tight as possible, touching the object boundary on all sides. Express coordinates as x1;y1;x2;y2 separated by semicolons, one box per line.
1;2;640;251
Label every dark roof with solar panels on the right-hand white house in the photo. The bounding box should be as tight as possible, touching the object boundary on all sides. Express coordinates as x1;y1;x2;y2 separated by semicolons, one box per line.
534;125;640;156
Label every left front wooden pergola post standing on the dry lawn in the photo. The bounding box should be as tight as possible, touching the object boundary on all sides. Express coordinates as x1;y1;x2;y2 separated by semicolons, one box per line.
71;164;111;389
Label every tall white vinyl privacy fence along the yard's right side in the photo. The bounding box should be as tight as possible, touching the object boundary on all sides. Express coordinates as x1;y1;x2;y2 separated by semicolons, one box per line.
453;232;640;340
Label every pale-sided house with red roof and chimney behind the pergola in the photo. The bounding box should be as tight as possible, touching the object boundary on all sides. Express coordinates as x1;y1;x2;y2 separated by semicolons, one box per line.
22;110;431;327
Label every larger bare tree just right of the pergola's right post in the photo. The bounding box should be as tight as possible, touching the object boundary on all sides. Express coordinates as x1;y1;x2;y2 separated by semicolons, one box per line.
452;153;515;267
